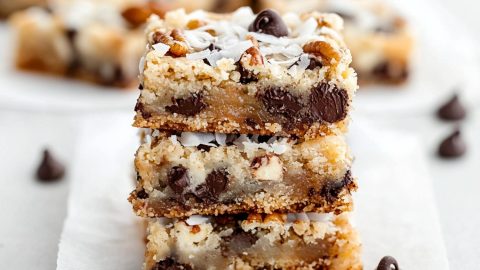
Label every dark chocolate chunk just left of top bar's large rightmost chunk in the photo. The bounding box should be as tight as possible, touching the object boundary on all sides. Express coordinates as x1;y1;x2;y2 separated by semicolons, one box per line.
262;87;302;119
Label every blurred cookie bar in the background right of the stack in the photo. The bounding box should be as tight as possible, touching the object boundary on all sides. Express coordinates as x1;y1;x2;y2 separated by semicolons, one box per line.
260;0;413;83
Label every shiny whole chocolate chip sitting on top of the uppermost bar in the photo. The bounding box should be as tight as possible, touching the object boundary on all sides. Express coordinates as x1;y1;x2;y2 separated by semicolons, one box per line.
248;9;288;37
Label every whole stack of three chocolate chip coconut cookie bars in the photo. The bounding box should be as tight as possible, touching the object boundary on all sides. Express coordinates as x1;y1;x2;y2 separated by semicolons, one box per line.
130;8;362;270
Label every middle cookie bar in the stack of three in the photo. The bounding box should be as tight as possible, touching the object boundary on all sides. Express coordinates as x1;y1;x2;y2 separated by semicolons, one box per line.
130;131;356;217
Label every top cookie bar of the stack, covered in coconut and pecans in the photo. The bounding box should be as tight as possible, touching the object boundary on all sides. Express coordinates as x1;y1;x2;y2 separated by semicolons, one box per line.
135;8;357;137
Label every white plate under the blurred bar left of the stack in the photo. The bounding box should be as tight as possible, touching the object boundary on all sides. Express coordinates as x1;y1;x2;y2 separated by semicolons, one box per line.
0;22;138;112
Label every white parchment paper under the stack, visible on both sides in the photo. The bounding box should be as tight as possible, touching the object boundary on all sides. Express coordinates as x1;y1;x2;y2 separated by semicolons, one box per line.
52;115;448;270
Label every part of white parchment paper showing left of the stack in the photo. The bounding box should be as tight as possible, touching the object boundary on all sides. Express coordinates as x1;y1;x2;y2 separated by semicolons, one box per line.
57;114;145;270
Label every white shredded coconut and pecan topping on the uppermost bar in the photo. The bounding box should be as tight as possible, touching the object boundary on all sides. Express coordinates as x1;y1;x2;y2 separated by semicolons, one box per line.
142;7;350;73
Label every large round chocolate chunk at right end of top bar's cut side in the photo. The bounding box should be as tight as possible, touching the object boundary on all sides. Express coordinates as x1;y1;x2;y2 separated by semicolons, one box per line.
309;83;348;123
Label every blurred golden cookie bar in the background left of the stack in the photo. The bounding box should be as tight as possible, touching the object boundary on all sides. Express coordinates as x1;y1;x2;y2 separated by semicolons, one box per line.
12;0;148;87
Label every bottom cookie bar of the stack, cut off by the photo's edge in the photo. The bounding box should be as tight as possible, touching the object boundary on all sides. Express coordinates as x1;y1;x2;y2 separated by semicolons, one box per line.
144;213;362;270
